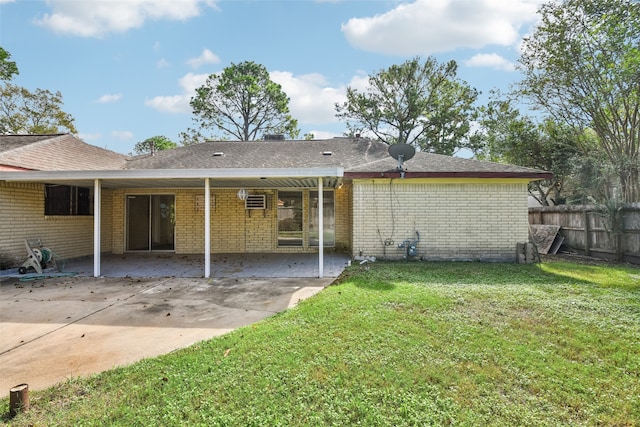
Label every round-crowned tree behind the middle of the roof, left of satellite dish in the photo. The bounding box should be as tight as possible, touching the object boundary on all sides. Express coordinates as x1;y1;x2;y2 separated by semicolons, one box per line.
183;61;300;143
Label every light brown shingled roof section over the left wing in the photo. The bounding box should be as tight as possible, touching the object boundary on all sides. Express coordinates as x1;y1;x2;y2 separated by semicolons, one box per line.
0;134;127;171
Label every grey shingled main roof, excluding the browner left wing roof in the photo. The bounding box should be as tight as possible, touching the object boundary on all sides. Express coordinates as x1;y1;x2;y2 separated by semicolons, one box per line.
127;138;549;179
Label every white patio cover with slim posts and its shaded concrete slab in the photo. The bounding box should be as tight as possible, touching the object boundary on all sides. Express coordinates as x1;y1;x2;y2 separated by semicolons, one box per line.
0;167;348;278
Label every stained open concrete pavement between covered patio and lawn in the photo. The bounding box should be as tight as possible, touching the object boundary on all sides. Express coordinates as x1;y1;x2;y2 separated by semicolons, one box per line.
0;274;344;393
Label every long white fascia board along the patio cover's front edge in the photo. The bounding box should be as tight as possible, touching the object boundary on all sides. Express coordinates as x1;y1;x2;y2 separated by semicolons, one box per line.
0;167;344;182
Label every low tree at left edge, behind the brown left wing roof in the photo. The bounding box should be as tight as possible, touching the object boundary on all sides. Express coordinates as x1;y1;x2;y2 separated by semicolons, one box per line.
0;83;78;134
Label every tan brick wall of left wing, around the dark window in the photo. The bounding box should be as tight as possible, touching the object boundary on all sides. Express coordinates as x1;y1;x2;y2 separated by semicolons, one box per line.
0;182;112;266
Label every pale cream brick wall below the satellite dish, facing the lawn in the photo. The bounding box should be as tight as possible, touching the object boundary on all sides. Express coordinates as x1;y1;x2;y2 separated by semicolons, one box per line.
353;179;528;261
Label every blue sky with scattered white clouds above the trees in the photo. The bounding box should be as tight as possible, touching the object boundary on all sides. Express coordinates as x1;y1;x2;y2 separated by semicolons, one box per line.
0;0;541;154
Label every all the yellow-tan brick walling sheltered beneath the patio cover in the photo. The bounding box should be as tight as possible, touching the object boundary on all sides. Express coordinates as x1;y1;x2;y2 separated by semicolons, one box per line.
0;182;352;266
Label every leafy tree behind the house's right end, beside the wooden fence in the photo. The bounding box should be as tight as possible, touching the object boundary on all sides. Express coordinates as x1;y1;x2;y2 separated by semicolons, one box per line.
471;92;579;206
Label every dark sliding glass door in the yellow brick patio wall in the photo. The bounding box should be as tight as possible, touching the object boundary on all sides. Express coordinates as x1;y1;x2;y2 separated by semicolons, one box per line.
126;194;175;252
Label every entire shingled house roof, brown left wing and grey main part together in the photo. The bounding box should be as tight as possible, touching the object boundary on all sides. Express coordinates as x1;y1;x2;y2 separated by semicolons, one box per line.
0;134;550;179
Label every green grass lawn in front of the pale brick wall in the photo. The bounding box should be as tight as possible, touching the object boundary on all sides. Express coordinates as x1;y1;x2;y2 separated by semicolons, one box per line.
0;262;640;426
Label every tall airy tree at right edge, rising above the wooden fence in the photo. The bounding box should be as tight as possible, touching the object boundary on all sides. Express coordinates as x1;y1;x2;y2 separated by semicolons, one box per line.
519;0;640;202
